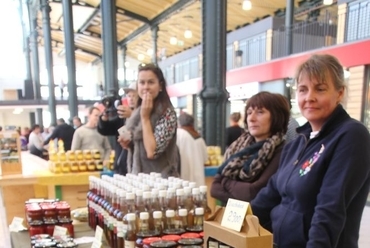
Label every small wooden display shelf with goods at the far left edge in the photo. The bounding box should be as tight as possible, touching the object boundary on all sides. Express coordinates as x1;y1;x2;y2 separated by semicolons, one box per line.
0;131;22;176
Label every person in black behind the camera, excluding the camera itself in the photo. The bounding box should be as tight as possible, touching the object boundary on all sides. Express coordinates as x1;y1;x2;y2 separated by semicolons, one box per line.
98;83;137;175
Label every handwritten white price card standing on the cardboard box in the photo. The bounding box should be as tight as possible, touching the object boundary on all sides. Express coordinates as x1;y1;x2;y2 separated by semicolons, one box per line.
221;198;251;232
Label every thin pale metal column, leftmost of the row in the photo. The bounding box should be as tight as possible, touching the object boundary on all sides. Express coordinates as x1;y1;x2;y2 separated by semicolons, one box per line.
27;1;43;125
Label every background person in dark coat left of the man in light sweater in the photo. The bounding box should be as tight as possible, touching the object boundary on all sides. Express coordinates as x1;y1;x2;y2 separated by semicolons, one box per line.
44;118;75;151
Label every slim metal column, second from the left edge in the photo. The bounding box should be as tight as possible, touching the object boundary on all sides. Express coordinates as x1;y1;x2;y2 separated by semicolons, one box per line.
40;0;57;124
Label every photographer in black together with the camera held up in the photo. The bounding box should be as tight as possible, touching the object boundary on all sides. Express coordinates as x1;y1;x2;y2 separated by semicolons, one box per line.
98;83;137;175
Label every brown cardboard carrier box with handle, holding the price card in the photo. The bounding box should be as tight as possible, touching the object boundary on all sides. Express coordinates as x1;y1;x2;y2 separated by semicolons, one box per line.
204;208;273;248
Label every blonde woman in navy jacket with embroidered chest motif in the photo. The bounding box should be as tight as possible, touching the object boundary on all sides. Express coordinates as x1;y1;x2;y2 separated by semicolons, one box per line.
252;55;370;248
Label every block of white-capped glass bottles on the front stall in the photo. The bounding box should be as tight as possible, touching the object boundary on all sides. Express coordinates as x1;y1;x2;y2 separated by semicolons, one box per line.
87;173;210;248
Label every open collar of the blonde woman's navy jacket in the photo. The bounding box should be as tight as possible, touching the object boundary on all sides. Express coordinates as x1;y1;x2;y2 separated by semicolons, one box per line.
297;104;351;137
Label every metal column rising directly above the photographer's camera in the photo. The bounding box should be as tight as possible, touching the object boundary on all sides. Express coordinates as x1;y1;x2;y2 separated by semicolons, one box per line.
101;0;118;92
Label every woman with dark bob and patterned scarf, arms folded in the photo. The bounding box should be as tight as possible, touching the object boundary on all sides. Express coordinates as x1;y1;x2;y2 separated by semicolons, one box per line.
211;91;289;204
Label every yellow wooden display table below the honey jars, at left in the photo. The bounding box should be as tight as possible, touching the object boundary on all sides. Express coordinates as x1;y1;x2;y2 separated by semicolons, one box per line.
0;152;100;225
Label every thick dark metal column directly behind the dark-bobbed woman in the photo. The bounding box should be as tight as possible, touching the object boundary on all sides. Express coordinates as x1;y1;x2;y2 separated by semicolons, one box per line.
200;0;227;150
